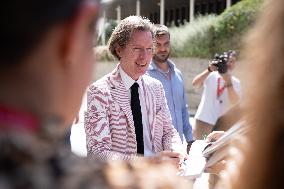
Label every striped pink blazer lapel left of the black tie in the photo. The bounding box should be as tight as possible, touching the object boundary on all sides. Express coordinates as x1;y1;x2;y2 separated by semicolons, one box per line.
110;66;135;133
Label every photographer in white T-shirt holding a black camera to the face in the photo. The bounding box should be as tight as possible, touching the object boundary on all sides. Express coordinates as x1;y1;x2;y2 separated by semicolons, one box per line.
192;51;241;139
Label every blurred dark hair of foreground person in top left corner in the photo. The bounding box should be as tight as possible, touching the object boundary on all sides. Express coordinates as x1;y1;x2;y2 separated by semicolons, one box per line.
0;0;83;67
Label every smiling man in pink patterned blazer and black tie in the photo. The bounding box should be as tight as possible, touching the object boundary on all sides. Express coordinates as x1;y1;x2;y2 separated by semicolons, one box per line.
85;16;181;167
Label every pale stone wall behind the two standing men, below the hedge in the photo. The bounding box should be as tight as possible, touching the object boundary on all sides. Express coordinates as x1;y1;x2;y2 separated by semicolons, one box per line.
93;58;208;115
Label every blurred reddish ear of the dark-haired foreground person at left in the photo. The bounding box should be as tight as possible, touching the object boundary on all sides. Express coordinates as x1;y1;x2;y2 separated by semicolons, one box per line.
59;2;99;64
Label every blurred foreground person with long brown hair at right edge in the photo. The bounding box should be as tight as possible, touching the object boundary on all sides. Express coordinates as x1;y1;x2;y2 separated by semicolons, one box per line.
217;0;284;189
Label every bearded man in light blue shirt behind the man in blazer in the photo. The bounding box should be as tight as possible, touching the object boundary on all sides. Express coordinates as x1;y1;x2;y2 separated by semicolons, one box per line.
147;25;193;153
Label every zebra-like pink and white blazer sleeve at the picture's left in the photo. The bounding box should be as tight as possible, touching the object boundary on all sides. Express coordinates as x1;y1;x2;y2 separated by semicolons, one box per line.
84;85;137;160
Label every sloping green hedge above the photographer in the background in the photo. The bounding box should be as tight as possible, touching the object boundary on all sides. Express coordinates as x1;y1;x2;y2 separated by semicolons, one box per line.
171;0;263;58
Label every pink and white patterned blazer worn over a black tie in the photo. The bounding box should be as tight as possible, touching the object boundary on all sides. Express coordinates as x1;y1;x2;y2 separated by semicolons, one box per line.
85;65;181;160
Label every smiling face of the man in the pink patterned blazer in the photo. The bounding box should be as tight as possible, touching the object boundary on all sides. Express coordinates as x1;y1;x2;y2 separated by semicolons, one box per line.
117;31;153;80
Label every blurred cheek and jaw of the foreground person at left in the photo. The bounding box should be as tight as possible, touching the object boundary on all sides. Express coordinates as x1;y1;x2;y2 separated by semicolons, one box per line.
64;13;98;126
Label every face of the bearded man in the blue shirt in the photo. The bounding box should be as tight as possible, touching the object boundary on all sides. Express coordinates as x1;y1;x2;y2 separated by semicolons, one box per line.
153;34;171;63
